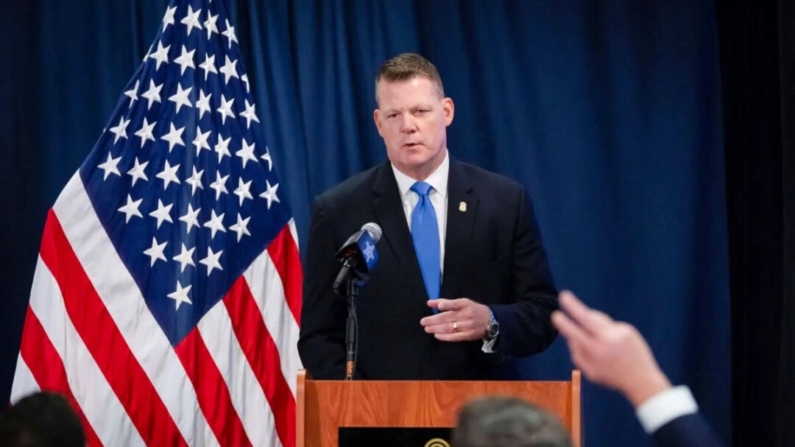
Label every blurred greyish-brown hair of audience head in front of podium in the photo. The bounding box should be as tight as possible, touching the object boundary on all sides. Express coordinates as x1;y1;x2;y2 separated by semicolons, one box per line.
452;396;572;447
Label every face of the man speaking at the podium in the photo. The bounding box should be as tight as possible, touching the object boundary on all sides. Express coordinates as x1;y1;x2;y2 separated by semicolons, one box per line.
373;76;453;180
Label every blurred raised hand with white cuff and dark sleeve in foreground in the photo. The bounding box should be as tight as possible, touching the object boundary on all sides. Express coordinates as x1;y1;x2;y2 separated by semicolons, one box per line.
552;291;722;447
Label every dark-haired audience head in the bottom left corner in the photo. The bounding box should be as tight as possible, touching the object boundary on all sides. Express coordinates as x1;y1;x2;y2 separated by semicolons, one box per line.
0;392;86;447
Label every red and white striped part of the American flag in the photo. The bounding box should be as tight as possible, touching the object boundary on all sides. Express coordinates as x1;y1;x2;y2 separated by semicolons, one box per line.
11;174;302;447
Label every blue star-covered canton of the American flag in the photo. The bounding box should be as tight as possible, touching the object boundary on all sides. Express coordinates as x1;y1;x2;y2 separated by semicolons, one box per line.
59;2;296;319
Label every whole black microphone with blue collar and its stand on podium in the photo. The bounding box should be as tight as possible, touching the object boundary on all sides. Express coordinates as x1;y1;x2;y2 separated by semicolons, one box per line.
334;222;381;380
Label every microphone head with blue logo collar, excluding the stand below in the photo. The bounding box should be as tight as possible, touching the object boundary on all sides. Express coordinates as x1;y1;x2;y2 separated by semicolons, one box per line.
334;222;382;295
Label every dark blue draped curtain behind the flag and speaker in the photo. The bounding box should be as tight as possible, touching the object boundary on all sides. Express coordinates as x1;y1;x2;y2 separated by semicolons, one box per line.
0;0;731;446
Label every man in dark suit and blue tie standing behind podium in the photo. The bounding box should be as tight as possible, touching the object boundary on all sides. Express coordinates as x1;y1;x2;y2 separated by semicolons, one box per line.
298;54;557;380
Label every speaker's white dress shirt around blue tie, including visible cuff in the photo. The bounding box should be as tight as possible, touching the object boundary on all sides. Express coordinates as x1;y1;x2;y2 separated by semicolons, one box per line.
392;151;496;353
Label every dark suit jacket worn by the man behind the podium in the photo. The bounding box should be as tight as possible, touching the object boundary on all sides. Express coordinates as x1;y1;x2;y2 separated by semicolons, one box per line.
298;157;557;380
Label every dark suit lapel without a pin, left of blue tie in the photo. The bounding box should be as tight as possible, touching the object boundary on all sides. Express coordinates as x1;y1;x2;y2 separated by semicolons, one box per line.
373;162;427;297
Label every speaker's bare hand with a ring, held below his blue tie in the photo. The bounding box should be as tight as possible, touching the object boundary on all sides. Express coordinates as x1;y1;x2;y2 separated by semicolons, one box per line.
420;298;491;341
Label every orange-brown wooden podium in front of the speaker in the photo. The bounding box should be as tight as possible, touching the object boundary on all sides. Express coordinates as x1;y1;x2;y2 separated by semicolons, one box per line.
296;370;581;447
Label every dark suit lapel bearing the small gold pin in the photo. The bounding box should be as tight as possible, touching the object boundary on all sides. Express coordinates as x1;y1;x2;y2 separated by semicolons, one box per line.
440;157;478;298
